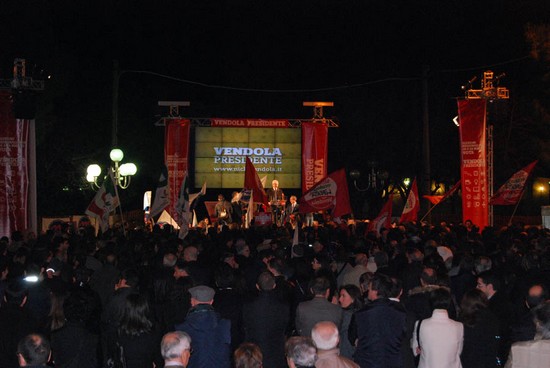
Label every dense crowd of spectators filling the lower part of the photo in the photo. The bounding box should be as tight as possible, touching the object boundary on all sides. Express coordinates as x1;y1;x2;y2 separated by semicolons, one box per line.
0;211;550;368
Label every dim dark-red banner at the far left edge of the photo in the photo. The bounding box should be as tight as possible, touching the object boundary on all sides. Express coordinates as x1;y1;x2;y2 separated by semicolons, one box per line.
0;92;29;236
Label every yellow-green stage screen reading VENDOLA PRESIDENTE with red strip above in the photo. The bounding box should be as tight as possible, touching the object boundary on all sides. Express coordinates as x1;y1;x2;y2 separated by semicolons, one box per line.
194;119;302;189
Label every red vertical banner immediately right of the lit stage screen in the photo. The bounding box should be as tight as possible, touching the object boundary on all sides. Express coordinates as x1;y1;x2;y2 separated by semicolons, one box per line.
302;123;328;193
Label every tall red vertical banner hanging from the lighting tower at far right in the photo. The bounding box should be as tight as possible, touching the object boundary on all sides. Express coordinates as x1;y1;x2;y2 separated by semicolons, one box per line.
458;99;489;229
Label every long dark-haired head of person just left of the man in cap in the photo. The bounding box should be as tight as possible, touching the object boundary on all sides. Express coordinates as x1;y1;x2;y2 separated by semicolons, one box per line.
119;293;153;336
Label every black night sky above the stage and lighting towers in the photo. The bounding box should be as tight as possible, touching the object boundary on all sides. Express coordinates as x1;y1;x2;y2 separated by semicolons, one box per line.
0;0;550;214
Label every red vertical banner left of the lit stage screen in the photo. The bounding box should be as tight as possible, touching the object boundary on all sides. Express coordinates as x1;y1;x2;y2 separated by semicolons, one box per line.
164;119;191;222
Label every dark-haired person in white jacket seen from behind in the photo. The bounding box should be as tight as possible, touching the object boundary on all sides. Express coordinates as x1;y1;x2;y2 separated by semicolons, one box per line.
411;287;464;368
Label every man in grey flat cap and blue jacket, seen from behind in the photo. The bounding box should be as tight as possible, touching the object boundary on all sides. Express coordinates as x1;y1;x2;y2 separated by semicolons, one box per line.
176;285;231;368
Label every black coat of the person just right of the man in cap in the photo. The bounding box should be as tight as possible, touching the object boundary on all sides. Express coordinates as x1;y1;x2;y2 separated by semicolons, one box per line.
243;291;290;368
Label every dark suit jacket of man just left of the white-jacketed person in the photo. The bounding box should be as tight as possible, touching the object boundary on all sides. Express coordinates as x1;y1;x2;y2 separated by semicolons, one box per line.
348;298;406;368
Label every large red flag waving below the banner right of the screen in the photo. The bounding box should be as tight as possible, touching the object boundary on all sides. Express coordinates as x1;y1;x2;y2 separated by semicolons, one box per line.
298;169;351;217
